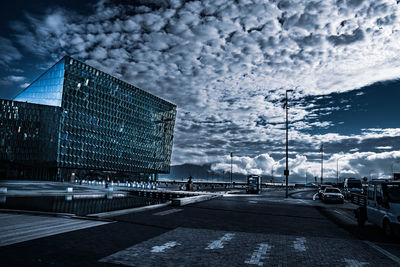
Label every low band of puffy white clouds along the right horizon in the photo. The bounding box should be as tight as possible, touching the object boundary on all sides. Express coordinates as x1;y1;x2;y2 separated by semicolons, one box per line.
211;151;400;182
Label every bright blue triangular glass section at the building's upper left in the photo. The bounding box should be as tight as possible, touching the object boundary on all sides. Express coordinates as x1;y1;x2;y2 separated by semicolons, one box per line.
14;59;65;107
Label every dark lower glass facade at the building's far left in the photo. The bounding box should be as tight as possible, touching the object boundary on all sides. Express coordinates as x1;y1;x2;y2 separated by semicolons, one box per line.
0;100;60;179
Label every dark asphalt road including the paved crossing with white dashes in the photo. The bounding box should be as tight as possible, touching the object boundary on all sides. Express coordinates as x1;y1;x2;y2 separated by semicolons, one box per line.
0;191;400;266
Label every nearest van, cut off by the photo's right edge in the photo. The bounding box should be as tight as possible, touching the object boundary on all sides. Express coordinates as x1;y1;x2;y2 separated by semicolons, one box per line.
356;180;400;236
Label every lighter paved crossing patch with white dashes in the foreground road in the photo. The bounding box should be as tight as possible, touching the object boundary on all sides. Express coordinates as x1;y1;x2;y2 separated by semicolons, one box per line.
100;228;395;266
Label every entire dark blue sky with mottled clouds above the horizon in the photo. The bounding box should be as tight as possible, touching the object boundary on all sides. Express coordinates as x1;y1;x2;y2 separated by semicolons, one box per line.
0;0;400;182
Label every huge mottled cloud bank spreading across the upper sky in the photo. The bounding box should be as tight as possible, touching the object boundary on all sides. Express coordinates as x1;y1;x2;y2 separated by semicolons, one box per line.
0;0;400;180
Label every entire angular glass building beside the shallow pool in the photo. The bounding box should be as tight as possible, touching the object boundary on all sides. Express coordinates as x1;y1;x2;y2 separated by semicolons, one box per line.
0;56;176;180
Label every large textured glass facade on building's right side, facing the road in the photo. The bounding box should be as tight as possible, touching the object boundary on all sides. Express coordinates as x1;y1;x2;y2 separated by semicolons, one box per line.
60;58;176;173
